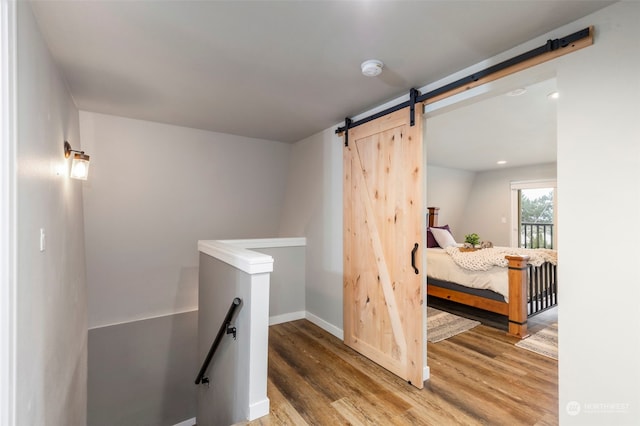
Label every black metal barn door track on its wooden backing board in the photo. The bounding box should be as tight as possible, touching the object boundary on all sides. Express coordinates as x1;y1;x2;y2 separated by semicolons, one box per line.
336;26;593;146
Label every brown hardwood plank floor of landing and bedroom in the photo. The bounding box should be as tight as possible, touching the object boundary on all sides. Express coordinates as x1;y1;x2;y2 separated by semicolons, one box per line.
240;308;558;426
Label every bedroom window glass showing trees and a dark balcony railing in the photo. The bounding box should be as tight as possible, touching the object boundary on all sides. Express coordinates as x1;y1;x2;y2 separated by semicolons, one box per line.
518;188;553;248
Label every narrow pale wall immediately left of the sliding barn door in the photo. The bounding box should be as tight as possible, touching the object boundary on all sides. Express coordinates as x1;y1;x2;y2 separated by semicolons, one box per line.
280;128;343;335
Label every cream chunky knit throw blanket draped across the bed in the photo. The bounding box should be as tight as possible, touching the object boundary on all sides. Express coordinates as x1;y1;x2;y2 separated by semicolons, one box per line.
445;247;558;271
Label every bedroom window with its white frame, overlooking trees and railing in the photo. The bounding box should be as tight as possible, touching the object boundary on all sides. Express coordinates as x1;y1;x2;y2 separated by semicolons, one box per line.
511;181;557;249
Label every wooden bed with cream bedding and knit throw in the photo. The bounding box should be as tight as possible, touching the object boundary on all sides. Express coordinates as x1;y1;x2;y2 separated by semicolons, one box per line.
426;207;558;338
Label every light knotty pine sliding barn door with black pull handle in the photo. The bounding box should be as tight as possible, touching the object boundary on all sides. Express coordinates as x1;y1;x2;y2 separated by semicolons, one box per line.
344;108;426;388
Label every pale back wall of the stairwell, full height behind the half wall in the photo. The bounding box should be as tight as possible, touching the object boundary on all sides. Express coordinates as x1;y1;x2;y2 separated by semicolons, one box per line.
80;111;292;425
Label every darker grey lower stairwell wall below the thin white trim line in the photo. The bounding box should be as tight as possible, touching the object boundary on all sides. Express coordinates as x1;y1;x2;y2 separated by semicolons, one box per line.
87;311;196;426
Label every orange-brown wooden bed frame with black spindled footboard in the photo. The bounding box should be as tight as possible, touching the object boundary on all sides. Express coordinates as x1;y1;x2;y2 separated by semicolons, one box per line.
427;207;558;339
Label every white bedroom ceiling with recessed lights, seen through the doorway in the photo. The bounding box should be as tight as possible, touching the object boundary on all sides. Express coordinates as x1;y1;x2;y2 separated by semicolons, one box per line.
426;78;557;171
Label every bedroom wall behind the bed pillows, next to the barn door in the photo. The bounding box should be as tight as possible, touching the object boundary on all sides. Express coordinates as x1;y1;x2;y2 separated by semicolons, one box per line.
425;164;476;241
